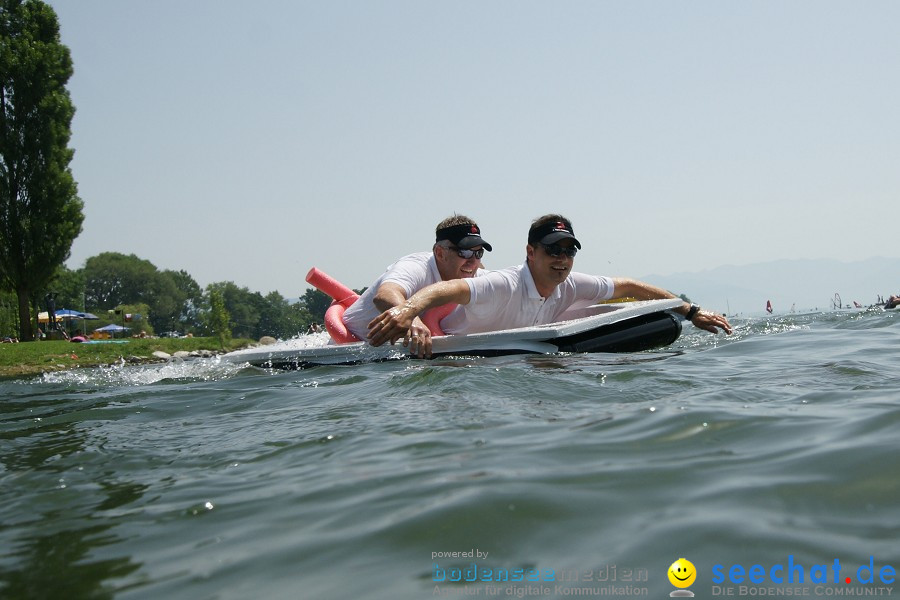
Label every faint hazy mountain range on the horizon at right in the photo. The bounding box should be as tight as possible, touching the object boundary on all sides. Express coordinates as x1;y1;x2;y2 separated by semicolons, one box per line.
640;258;900;315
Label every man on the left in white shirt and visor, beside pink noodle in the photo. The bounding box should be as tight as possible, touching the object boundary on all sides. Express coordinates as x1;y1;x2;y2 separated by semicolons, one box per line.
343;215;492;355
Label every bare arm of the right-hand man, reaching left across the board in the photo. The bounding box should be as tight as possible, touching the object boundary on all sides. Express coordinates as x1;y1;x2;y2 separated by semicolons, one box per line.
368;279;471;357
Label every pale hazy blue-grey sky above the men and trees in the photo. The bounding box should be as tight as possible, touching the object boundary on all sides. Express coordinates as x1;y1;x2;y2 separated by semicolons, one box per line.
50;0;900;297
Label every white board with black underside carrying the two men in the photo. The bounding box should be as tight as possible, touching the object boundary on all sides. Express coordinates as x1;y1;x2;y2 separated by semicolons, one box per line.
222;298;683;369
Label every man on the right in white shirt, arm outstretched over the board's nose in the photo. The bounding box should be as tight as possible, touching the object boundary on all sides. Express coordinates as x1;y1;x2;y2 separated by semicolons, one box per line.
367;215;732;357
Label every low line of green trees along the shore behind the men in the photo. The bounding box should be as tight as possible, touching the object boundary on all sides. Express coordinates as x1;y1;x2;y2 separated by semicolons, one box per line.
0;252;340;340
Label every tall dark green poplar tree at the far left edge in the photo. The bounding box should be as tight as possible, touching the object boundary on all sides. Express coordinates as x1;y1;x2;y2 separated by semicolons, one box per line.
0;0;84;340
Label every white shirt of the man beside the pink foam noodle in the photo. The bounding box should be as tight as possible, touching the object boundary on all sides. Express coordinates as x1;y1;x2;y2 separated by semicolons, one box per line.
344;252;441;340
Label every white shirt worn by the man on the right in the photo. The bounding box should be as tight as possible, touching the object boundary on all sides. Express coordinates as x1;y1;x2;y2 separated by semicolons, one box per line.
441;262;615;334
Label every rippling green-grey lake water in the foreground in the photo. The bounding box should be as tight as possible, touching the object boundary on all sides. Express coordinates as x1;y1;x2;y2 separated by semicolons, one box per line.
0;310;900;600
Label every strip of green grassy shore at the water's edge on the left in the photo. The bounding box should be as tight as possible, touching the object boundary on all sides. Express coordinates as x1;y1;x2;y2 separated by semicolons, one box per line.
0;337;251;379
